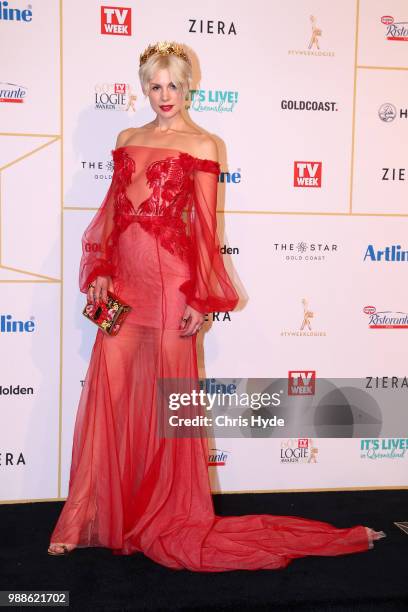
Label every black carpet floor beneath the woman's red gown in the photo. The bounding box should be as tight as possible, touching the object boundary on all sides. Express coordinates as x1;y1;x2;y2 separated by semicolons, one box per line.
0;490;408;612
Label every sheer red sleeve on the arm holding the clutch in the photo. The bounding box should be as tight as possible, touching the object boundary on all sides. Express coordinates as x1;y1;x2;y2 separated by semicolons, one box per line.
79;148;134;293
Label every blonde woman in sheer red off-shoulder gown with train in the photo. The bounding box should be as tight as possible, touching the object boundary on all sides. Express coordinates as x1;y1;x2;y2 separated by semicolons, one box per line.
48;43;383;572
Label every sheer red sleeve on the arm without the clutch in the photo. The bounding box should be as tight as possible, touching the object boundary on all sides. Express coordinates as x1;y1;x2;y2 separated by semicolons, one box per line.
181;159;239;313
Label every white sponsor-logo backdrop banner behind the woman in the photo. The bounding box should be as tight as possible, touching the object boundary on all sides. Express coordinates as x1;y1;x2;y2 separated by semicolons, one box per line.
0;0;408;502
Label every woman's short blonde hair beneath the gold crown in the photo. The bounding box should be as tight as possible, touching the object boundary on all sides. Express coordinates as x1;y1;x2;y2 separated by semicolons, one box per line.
139;53;192;95
